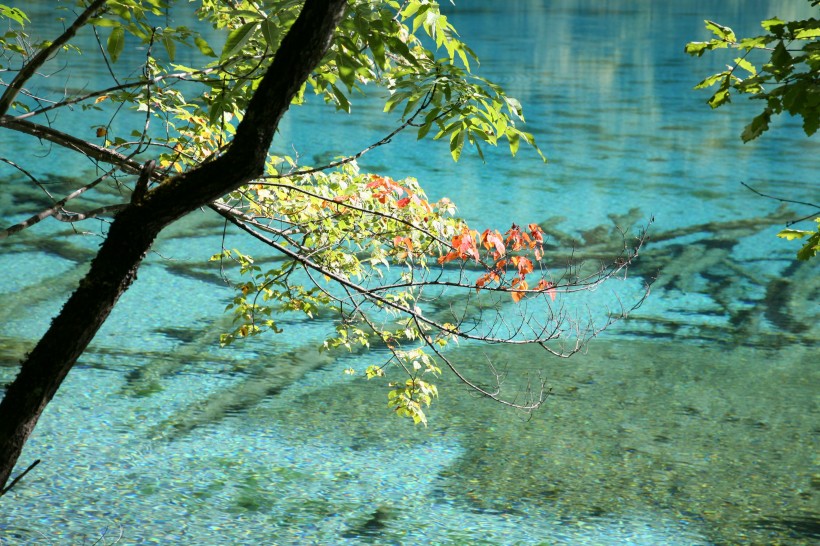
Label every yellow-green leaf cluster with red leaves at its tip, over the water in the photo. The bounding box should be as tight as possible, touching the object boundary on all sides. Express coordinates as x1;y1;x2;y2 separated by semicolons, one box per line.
213;158;576;423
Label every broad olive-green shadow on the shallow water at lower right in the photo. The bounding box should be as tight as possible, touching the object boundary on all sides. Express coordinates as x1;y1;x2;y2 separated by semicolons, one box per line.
255;341;820;544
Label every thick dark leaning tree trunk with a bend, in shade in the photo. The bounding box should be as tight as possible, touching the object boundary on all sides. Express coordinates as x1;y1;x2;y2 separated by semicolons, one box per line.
0;0;346;489
